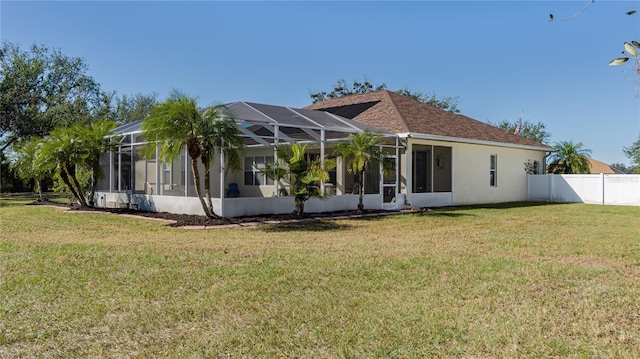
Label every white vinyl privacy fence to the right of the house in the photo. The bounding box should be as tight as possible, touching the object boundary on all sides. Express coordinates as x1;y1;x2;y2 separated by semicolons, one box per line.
527;174;640;206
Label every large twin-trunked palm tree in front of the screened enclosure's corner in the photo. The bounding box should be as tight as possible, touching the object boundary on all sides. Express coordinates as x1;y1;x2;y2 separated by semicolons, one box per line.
142;91;242;217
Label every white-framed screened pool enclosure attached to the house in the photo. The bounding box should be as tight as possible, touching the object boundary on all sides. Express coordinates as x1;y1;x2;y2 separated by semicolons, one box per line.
95;102;404;217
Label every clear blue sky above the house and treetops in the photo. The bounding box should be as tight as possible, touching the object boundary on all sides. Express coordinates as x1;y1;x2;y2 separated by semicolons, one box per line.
0;0;640;164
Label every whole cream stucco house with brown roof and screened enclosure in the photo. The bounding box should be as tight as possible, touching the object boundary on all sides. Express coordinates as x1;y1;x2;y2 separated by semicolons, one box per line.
96;90;553;217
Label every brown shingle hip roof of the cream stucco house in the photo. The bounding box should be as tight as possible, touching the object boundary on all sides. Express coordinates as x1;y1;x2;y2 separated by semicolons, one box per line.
305;90;554;151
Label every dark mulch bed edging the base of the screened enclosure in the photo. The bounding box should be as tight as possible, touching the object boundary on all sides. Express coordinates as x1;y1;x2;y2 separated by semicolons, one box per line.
27;200;404;227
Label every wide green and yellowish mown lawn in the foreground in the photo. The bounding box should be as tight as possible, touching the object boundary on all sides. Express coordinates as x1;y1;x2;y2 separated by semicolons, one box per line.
0;198;640;358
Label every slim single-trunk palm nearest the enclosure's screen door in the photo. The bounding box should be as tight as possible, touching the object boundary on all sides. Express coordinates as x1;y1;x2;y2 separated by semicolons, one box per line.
334;131;387;212
